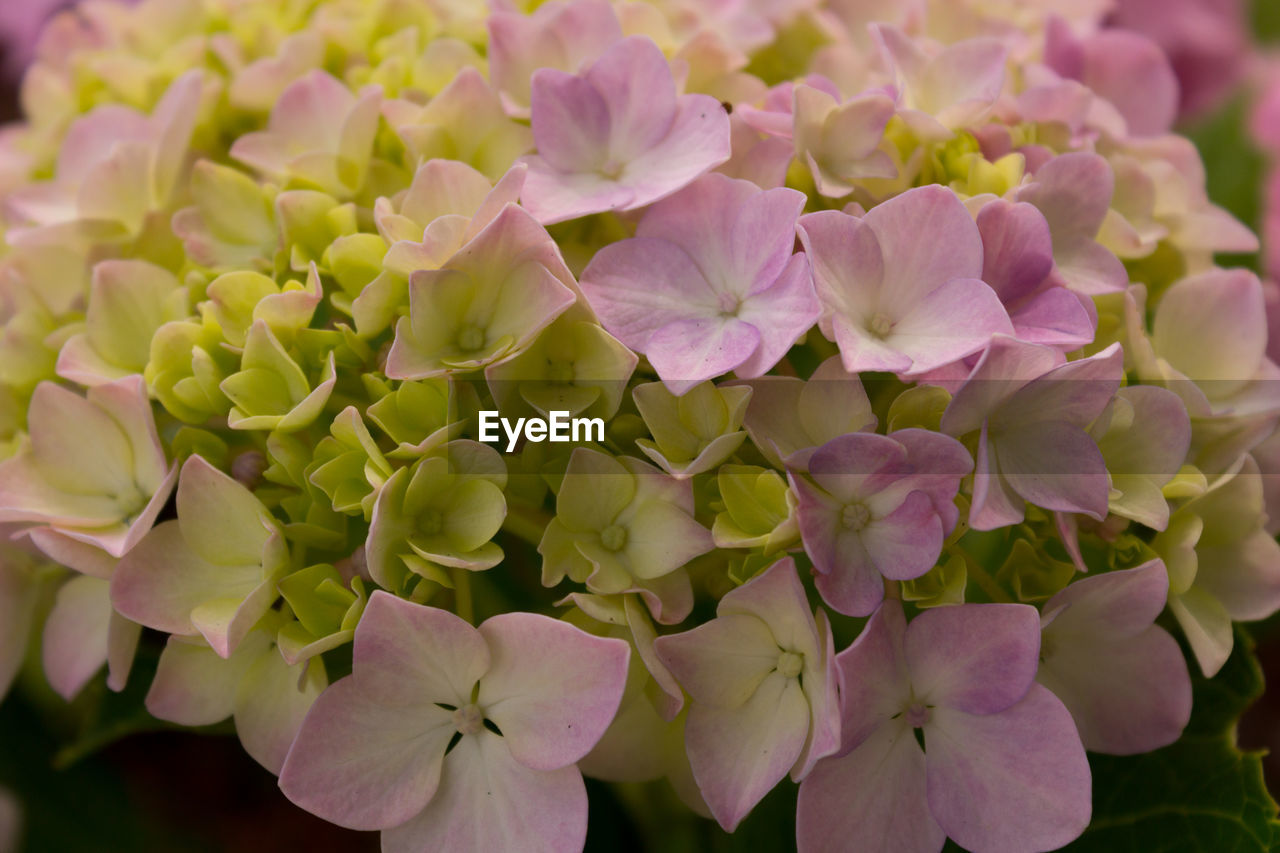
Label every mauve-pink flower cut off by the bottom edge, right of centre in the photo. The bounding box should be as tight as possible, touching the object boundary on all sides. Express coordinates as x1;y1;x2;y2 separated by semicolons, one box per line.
796;601;1092;853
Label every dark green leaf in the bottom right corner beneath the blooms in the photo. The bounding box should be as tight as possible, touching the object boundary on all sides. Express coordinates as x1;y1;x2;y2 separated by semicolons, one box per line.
1065;628;1280;853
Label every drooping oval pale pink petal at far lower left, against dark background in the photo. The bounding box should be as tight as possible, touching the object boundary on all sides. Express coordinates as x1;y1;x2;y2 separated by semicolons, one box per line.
41;575;111;702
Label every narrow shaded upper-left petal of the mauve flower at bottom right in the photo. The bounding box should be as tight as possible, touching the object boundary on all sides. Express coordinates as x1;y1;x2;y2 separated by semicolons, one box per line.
836;599;911;752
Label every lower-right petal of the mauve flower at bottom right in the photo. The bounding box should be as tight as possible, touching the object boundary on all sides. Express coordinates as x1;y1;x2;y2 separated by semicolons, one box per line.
924;684;1092;852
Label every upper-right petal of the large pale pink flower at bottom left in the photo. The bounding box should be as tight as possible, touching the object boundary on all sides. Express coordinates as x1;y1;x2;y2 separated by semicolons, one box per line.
476;613;631;770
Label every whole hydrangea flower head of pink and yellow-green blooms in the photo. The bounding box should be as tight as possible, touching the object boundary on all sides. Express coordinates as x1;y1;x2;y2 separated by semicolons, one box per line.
0;0;1280;853
